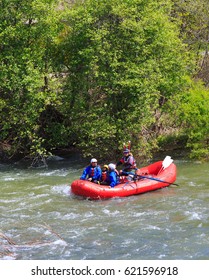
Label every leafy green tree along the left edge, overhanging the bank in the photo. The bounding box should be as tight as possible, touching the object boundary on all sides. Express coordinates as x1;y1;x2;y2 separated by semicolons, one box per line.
0;0;65;158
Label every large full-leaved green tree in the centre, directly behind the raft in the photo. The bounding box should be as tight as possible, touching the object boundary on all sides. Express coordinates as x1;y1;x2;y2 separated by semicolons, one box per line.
59;0;188;160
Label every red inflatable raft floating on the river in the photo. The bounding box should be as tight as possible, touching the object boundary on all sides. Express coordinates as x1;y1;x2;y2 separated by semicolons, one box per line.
71;161;177;200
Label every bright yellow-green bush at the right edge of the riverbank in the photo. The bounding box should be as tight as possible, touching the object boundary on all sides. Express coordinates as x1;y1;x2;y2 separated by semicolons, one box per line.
178;82;209;159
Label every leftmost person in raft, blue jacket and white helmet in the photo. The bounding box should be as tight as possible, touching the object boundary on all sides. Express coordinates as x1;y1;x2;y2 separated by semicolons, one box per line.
80;158;102;184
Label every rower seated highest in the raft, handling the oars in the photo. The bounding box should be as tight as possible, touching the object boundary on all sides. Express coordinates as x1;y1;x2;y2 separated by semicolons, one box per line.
116;148;137;176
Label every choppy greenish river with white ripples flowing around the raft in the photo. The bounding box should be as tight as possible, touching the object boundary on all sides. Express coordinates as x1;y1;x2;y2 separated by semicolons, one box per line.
0;154;209;260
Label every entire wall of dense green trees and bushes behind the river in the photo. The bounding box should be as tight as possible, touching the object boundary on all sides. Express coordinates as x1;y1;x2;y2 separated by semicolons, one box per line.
0;0;209;161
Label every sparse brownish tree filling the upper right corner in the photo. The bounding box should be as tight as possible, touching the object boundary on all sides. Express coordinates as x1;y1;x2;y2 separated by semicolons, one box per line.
171;0;209;86
